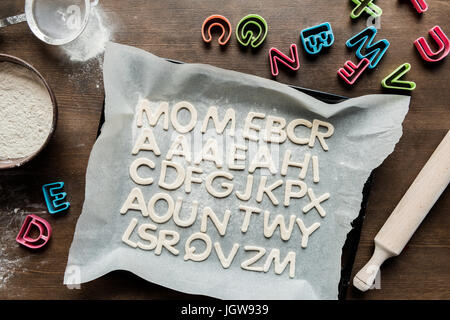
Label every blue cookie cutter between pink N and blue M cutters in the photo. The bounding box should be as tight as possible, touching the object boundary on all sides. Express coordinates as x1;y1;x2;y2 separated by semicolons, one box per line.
300;22;334;54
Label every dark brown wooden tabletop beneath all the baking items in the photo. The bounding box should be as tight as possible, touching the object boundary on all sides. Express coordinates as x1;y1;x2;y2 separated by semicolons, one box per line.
0;0;450;299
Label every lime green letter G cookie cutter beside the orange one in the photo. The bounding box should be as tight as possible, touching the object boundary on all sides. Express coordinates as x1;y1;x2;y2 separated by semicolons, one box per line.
236;14;269;48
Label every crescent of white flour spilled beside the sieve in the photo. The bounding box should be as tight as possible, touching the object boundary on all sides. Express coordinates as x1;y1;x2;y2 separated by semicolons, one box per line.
61;5;112;62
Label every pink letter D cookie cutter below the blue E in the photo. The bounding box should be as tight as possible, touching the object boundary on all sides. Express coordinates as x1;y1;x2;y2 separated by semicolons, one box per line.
16;214;52;249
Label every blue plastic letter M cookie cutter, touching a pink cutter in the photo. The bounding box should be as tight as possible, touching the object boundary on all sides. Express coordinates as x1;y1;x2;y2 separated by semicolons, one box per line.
346;26;389;69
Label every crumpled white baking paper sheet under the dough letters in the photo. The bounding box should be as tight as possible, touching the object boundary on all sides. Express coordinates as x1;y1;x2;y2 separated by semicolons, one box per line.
64;43;409;299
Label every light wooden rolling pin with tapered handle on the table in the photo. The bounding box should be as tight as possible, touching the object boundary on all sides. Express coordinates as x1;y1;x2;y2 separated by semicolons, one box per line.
353;131;450;291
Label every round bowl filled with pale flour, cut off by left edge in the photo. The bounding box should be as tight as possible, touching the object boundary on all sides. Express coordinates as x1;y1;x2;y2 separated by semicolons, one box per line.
0;54;58;170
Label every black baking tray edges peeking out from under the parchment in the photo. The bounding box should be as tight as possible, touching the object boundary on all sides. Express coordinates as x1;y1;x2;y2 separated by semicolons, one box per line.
97;63;373;300
